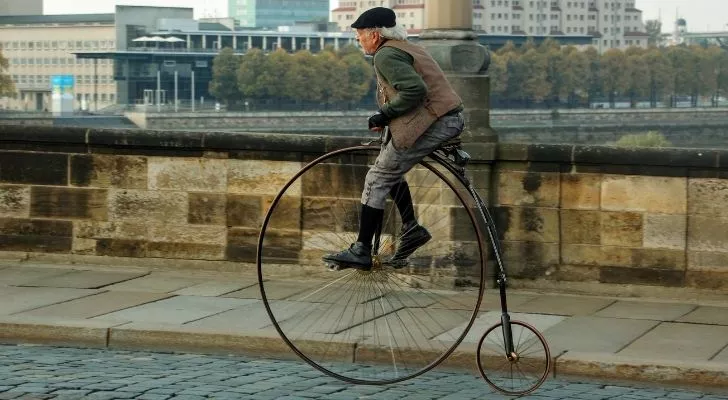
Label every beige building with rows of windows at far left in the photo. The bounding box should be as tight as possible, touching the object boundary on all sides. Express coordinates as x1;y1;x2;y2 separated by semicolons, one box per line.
0;14;116;111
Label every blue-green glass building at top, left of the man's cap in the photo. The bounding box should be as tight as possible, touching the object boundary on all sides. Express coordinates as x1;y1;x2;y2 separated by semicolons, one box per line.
228;0;329;29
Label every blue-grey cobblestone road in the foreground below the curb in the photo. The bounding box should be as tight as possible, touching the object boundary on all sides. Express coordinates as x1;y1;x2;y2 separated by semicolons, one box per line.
0;346;728;400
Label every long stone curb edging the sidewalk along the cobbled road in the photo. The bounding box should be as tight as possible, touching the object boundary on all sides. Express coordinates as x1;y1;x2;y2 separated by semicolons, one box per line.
0;317;728;387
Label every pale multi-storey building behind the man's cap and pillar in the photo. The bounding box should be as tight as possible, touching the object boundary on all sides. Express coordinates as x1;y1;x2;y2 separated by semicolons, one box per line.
331;0;648;52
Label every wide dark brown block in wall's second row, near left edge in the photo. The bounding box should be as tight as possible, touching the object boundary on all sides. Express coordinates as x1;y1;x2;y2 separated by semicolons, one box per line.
30;186;108;221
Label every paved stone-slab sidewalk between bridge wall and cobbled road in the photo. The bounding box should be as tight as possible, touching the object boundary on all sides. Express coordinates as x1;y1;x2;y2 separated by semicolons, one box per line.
0;262;728;387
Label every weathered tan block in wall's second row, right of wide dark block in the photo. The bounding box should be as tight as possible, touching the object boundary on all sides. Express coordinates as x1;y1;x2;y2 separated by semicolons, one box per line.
109;189;188;224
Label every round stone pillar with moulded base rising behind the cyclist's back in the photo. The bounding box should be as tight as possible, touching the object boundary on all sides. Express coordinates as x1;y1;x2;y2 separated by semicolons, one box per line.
419;0;498;150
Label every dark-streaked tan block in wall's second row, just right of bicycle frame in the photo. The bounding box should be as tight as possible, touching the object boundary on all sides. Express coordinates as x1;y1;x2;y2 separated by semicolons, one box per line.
496;207;559;242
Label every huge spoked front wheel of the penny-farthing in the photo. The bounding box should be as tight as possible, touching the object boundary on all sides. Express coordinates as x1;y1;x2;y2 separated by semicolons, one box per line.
257;146;485;384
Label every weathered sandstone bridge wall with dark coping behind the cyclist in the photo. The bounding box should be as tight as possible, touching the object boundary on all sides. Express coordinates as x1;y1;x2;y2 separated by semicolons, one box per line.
0;126;728;289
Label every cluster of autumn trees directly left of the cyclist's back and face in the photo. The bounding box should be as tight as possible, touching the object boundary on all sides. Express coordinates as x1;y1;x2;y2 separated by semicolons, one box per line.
210;46;373;107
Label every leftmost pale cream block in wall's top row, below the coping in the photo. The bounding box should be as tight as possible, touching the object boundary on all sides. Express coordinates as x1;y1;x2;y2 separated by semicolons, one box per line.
147;157;228;193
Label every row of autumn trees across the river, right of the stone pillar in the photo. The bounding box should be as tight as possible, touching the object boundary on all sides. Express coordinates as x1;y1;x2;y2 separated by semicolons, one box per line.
490;40;728;107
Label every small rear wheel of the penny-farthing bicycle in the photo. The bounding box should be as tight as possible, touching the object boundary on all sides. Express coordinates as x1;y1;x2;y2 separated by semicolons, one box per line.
477;321;551;396
